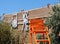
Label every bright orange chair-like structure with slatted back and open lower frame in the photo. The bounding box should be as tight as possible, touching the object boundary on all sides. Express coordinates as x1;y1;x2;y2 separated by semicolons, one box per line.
29;19;50;44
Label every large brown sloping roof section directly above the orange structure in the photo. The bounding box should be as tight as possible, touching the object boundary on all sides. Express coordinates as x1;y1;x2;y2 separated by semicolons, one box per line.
28;7;51;19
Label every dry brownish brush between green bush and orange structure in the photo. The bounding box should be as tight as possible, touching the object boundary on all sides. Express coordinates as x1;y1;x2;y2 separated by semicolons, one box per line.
12;29;29;44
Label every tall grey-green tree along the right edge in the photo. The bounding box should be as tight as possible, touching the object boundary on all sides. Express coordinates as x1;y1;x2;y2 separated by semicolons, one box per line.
46;5;60;44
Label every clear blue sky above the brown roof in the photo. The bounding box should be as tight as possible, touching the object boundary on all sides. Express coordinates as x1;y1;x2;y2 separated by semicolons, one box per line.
0;0;58;16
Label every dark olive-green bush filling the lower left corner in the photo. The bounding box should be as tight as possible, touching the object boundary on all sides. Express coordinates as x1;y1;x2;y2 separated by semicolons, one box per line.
0;22;11;44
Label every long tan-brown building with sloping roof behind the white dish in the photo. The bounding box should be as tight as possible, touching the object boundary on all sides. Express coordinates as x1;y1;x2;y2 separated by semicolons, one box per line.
3;4;53;29
